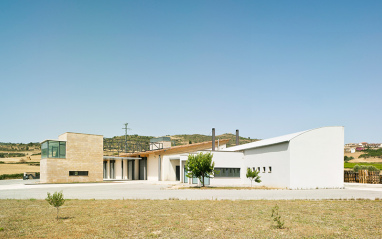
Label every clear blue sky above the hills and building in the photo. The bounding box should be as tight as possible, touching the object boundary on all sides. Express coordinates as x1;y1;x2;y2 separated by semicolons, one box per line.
0;0;382;143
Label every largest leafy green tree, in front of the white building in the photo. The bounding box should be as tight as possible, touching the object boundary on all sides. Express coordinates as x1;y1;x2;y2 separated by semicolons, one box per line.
186;153;215;187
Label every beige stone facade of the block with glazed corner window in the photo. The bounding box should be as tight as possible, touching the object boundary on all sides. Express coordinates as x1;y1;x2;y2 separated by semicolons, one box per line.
40;133;103;183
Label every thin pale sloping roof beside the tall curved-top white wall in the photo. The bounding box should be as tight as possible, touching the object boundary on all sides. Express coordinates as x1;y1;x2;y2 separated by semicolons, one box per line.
224;130;310;152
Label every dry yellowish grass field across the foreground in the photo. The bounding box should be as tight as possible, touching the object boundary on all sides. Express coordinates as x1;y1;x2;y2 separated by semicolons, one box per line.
0;200;382;238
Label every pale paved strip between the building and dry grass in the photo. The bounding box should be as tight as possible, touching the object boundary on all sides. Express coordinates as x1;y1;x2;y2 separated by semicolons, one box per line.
0;179;382;200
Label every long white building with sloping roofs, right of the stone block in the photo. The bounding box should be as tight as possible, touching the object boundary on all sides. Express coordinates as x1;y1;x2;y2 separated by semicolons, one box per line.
115;126;344;189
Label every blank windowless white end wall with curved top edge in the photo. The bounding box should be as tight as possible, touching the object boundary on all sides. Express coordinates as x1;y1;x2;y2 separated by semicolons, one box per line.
290;126;344;189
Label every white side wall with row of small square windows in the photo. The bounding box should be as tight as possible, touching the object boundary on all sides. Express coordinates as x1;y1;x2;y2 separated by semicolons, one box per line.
244;142;289;188
